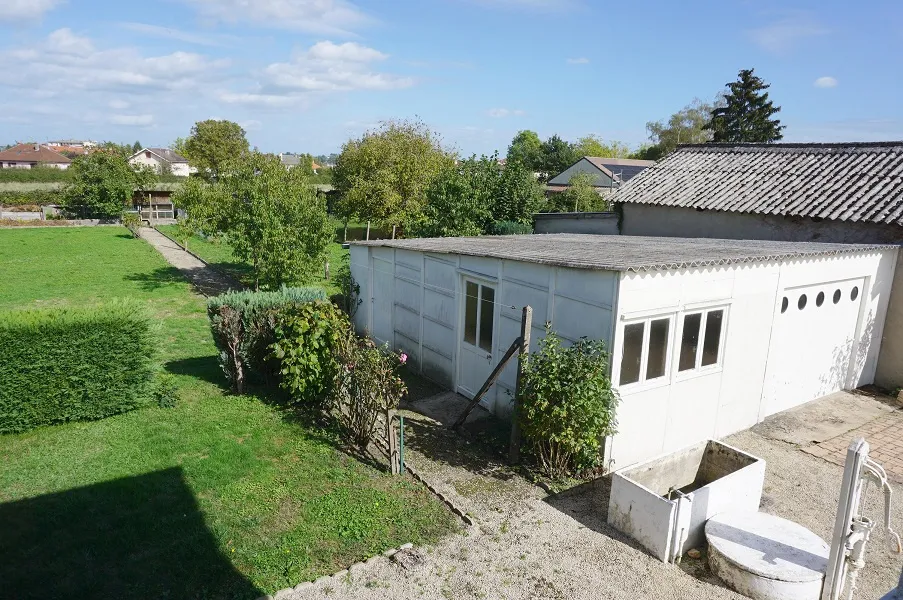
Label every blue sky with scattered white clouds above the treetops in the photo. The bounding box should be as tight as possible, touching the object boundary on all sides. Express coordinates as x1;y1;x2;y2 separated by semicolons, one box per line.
0;0;903;154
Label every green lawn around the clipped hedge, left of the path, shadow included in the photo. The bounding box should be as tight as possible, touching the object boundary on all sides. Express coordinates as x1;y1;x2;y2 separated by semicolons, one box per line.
0;227;455;598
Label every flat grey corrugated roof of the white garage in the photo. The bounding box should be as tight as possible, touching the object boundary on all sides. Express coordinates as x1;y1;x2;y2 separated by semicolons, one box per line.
353;233;896;272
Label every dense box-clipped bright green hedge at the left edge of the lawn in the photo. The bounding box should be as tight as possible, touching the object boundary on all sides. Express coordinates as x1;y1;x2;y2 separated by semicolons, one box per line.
0;302;157;433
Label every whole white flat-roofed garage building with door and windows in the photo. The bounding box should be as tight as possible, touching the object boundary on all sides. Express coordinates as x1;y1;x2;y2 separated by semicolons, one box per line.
351;234;897;468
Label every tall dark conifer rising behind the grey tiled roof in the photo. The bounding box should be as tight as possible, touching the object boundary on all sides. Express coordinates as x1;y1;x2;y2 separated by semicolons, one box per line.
706;69;784;143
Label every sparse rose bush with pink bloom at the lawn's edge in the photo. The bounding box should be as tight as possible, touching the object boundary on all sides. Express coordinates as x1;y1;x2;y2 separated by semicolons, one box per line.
333;331;408;448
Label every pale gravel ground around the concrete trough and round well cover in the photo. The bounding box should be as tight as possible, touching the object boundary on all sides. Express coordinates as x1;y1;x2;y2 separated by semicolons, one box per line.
279;394;903;600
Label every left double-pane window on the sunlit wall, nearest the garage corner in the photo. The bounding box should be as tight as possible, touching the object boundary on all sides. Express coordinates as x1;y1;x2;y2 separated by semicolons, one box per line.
619;317;671;385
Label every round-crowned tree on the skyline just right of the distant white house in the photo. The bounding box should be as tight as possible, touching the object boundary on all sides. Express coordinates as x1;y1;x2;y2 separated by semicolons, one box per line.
176;119;250;181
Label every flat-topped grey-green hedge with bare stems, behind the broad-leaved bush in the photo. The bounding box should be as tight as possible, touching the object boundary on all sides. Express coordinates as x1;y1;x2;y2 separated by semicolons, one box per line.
207;287;326;394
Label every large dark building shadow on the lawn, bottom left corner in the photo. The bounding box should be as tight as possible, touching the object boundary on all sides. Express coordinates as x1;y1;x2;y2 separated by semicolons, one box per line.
0;468;262;600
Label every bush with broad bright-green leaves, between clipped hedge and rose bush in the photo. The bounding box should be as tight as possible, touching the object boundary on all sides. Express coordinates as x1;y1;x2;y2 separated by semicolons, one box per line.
271;301;352;410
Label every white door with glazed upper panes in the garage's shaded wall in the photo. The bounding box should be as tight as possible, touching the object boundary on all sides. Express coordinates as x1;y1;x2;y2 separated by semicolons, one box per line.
458;279;495;410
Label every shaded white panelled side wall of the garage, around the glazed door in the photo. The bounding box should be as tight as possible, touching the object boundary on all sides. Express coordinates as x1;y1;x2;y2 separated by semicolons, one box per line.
351;245;617;417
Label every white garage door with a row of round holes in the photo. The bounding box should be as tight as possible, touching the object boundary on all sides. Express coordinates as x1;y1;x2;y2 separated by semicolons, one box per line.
762;279;865;416
